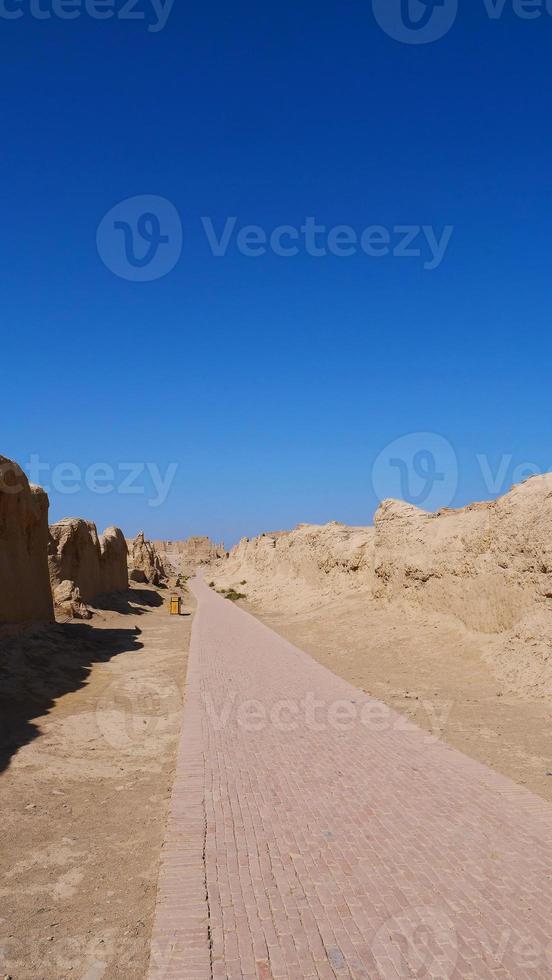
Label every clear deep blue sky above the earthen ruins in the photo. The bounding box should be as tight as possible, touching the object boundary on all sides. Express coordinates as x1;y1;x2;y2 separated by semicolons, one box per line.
0;0;552;543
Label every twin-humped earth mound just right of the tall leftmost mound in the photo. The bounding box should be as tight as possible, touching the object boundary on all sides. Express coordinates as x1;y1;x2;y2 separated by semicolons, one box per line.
48;517;128;617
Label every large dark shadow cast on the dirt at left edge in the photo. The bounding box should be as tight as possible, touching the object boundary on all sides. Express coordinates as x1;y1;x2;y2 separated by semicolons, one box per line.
0;620;144;772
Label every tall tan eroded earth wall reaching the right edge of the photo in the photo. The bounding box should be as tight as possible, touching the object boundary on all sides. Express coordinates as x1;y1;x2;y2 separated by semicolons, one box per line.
375;475;552;633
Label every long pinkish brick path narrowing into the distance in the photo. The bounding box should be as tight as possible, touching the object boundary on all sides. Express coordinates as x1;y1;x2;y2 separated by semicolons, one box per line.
150;579;552;980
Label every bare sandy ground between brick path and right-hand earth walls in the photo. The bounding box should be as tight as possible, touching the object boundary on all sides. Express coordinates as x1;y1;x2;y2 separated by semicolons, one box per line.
247;592;552;800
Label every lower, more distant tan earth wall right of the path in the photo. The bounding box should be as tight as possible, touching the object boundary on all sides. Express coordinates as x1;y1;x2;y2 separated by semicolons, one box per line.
214;521;374;608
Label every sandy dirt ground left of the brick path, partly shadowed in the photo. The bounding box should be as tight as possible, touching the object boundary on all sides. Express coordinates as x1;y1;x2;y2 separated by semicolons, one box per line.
0;587;193;980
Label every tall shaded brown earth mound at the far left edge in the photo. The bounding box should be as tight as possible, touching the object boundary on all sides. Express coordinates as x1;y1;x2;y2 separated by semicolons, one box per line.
0;456;54;623
